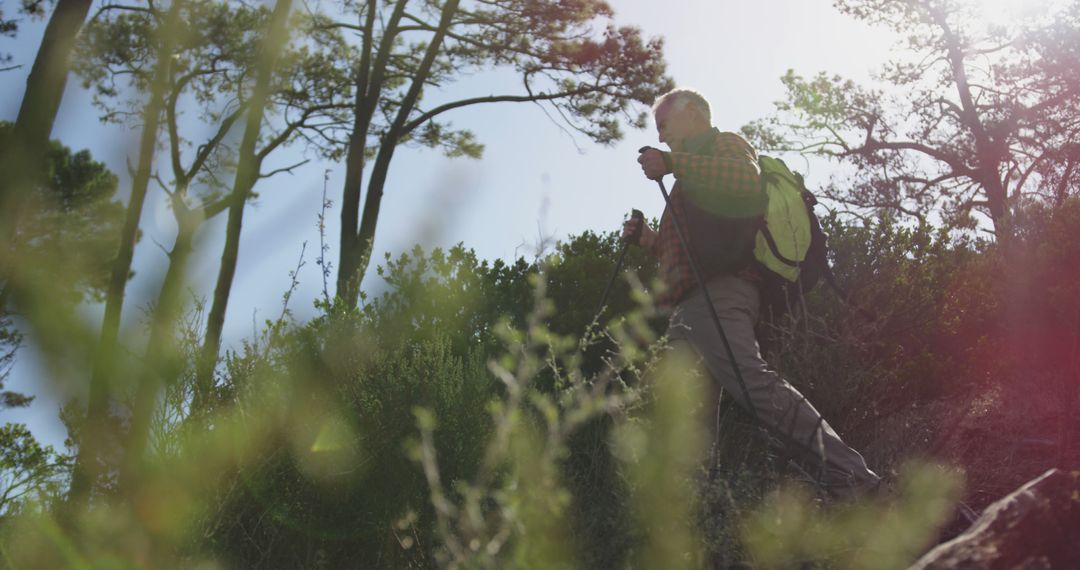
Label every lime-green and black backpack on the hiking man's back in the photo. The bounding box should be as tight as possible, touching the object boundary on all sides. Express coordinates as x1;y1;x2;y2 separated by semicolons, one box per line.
754;155;832;294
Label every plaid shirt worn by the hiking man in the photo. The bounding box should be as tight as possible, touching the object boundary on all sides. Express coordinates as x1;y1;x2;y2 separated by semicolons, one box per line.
651;127;761;307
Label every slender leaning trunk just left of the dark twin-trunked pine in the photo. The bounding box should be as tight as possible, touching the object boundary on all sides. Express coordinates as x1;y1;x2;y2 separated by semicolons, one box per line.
192;0;293;413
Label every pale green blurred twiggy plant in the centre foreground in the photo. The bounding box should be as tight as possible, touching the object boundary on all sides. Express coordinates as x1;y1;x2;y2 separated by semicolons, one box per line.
406;259;656;568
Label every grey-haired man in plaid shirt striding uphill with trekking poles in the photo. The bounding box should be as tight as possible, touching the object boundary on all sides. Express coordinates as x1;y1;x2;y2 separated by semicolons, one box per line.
623;89;879;497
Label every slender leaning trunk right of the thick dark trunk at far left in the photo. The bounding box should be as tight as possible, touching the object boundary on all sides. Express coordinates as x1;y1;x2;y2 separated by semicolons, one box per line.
69;0;184;508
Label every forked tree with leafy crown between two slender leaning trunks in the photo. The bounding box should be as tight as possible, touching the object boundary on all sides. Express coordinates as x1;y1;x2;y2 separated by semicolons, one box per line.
70;2;348;494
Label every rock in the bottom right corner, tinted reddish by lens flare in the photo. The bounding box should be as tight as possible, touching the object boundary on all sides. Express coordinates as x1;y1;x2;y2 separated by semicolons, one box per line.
910;469;1080;570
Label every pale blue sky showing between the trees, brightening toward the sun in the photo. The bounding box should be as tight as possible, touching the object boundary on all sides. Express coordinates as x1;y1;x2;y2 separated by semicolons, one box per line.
0;0;954;447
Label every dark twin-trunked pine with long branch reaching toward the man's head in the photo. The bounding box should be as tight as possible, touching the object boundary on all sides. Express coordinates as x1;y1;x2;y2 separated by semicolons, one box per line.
324;0;672;307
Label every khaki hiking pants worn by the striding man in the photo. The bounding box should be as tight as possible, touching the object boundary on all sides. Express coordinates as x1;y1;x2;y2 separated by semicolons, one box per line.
667;275;879;497
